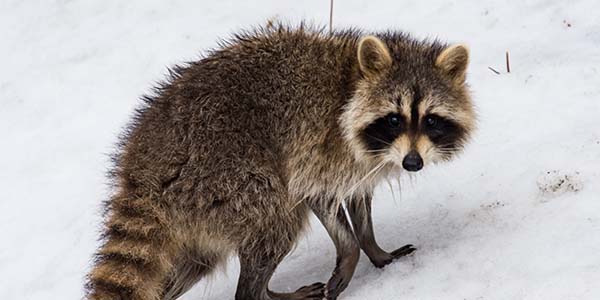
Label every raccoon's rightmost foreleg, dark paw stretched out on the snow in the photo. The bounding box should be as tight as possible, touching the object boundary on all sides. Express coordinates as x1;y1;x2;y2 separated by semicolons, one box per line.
348;195;416;268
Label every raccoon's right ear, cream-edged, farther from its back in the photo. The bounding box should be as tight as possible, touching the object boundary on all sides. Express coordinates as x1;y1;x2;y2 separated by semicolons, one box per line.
435;44;469;84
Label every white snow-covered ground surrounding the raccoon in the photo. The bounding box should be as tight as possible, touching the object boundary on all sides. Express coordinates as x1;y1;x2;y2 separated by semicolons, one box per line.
0;0;600;300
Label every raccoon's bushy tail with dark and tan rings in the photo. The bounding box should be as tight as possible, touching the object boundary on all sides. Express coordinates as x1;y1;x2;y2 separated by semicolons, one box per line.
86;197;175;300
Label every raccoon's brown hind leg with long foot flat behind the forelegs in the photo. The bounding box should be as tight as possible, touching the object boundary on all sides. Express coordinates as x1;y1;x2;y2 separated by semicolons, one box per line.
235;173;324;300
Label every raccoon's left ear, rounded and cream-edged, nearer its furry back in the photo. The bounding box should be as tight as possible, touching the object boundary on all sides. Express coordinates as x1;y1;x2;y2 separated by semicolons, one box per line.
358;35;392;77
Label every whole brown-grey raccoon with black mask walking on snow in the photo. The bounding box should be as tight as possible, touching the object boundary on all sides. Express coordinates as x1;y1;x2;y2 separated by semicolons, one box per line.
86;24;475;300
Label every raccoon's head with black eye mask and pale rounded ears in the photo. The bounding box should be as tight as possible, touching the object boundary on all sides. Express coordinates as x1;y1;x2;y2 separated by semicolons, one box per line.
341;34;475;172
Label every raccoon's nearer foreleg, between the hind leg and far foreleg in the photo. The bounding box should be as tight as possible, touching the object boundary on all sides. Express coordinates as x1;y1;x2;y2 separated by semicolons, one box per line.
309;201;360;299
